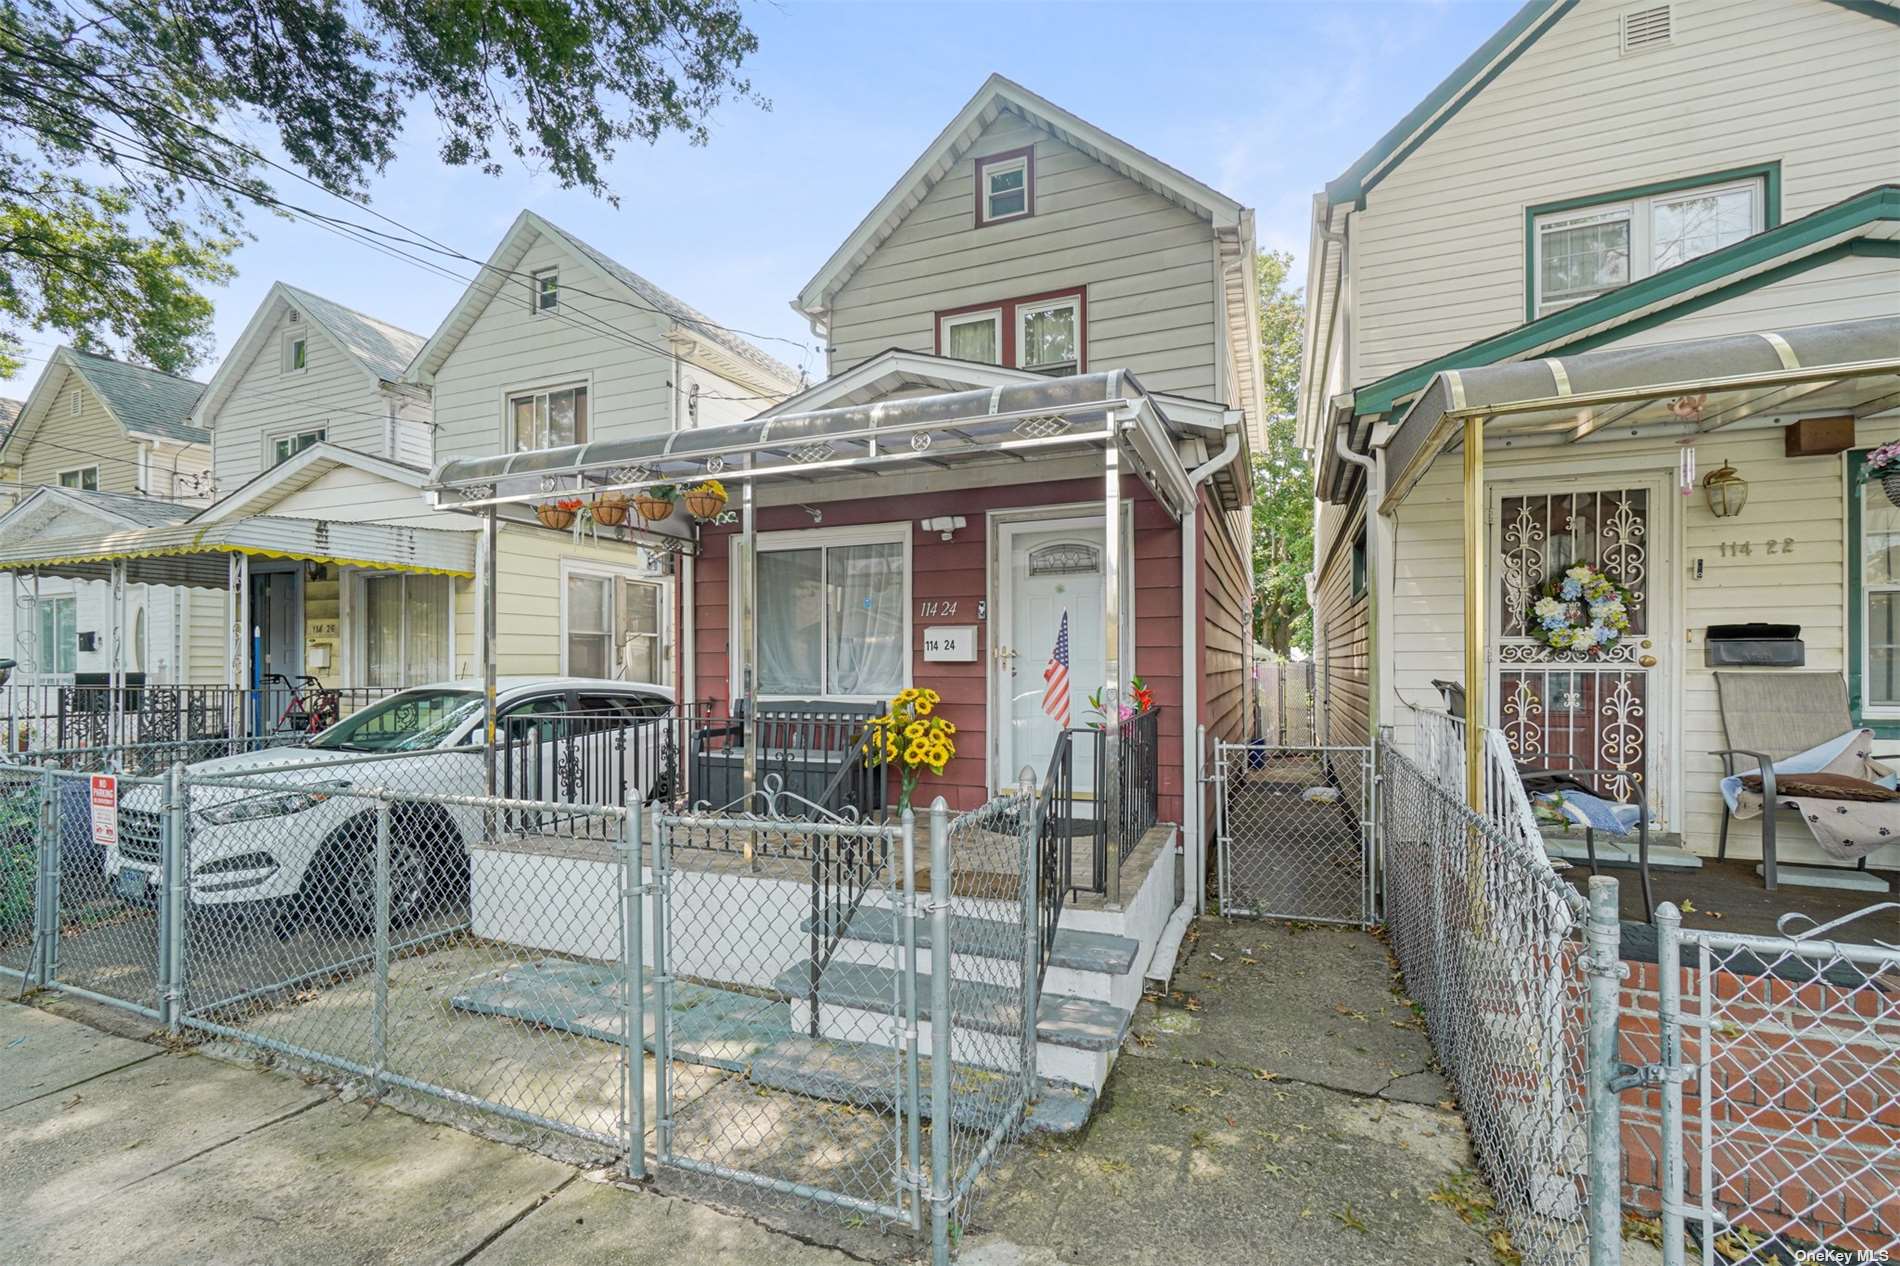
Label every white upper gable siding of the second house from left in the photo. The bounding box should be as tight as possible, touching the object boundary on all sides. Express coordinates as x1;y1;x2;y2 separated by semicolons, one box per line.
205;314;390;496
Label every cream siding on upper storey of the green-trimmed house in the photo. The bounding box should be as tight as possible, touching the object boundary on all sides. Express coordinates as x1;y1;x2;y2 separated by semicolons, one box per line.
1351;0;1900;384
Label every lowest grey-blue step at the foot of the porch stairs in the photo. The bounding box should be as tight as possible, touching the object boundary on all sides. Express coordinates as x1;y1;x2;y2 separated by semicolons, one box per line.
745;1034;1094;1135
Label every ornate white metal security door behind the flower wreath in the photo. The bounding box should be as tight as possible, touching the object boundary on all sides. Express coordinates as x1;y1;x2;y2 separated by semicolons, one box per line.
1492;487;1664;812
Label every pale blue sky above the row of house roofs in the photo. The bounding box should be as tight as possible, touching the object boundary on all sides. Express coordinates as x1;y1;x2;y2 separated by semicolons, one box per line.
0;0;1518;395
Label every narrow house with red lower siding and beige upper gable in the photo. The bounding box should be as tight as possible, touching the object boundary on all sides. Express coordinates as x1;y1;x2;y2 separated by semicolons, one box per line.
431;76;1260;1041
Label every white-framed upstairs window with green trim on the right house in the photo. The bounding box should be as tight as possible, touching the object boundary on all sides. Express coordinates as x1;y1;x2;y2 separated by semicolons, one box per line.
1531;179;1767;316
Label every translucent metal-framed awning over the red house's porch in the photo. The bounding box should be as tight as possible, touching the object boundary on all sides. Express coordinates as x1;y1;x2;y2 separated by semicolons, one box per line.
431;369;1188;534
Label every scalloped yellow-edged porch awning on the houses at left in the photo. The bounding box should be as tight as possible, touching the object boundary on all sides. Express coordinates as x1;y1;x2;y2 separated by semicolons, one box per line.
0;515;475;589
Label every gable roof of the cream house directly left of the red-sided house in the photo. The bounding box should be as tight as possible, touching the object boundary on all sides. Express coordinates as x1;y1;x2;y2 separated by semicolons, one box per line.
403;211;798;393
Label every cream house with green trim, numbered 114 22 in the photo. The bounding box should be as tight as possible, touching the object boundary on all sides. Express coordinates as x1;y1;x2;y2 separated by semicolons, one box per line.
1300;0;1900;865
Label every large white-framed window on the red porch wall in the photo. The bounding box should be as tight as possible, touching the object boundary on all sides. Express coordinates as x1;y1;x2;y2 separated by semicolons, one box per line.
756;523;910;700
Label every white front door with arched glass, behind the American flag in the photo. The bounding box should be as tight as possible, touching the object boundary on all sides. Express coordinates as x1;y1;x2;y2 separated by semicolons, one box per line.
994;517;1104;791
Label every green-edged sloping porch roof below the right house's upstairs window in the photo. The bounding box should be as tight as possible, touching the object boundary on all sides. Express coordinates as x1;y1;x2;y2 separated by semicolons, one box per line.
1353;184;1900;414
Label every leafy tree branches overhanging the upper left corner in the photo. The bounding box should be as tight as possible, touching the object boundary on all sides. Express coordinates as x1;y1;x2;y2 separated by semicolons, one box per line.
0;0;766;376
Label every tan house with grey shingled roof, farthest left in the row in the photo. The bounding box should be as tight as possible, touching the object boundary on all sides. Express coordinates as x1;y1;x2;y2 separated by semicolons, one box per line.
0;348;215;682
